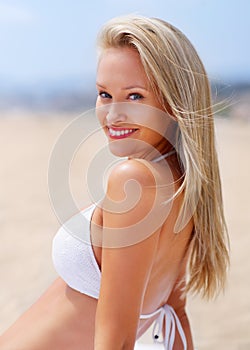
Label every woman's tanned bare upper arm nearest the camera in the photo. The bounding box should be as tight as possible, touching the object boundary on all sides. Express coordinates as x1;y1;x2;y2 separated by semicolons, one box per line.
97;161;168;346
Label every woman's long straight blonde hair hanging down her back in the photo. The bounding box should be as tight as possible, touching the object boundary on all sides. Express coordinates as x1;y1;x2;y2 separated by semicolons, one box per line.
98;15;229;298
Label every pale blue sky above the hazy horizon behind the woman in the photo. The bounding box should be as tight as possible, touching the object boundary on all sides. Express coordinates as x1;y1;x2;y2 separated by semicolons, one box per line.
0;0;250;90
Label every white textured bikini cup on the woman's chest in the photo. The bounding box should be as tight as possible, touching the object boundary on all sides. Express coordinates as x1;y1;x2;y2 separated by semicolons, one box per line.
52;204;101;299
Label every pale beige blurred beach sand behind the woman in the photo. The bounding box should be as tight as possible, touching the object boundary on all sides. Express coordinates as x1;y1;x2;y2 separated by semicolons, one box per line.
0;110;250;350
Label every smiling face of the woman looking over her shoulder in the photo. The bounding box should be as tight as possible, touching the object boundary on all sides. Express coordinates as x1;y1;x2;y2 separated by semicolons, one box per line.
96;47;170;158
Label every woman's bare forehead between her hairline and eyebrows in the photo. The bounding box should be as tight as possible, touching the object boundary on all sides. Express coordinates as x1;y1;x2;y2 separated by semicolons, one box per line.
97;47;147;84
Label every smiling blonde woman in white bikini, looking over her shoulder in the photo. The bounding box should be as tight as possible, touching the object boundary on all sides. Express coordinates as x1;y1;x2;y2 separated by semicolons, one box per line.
0;16;229;350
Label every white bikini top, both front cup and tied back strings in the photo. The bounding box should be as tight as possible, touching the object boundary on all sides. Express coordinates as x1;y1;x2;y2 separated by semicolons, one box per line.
52;151;187;350
